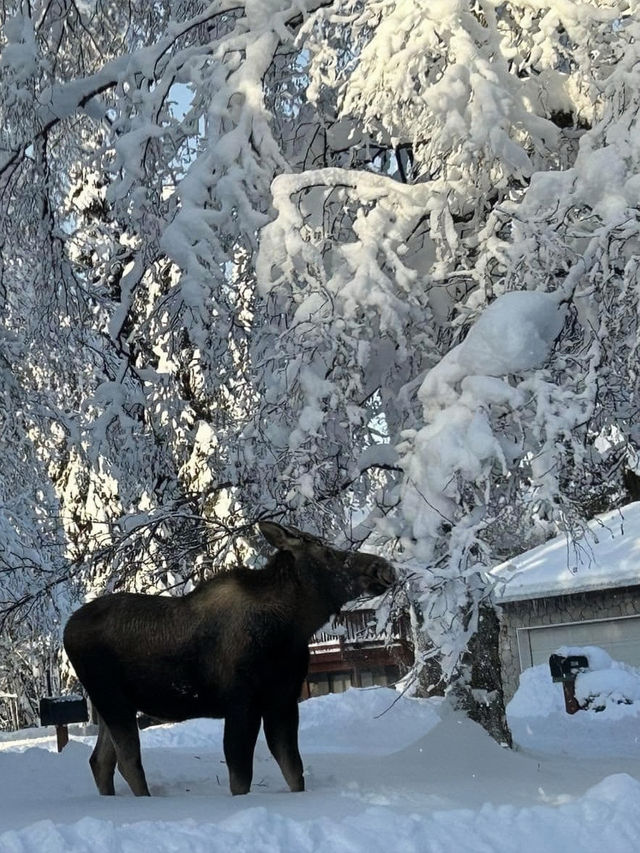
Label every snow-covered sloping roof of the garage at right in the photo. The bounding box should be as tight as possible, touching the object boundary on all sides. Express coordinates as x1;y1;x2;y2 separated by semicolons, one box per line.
489;502;640;603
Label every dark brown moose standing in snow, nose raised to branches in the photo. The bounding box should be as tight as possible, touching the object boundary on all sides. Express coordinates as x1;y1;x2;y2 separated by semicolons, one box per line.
64;521;396;796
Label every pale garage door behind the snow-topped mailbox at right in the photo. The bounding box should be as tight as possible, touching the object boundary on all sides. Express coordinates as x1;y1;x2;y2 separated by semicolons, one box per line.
518;616;640;670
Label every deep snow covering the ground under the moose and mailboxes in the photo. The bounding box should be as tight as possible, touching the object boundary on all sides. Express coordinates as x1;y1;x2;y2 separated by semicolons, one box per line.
0;656;640;853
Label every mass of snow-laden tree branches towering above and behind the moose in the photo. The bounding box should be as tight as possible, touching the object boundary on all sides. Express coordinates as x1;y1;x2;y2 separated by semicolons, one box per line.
0;0;640;732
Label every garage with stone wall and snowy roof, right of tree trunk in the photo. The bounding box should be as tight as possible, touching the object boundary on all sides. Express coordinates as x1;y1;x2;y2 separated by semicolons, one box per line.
489;502;640;701
